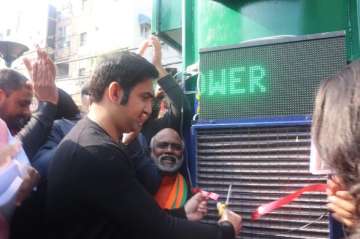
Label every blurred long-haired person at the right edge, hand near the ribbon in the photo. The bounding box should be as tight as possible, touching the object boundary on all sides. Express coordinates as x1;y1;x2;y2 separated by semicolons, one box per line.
312;62;360;238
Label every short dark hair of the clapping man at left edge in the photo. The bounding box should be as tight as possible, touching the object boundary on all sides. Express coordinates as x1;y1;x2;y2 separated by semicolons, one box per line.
0;69;28;95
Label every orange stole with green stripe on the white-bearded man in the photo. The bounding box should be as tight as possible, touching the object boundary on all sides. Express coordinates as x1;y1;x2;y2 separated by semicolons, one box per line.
155;173;188;209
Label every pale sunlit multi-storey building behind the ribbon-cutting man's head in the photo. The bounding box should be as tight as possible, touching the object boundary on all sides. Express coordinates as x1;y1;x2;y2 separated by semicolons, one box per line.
54;0;181;103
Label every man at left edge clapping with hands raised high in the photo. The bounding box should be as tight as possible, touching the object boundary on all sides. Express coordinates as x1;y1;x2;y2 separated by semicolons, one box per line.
0;49;79;239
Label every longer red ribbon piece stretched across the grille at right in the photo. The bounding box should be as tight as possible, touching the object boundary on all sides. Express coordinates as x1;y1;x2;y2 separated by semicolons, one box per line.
251;184;327;220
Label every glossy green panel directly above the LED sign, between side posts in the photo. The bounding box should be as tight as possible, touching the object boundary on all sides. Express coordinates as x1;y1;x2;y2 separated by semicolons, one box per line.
197;0;348;48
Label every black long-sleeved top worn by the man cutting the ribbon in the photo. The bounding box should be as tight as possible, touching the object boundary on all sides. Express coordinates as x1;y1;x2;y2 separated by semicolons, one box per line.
46;118;234;239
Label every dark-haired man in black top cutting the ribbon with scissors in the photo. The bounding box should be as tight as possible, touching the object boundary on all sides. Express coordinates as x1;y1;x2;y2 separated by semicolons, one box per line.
46;53;241;239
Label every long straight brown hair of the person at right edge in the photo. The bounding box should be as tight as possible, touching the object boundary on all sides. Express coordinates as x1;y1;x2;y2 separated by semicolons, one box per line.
312;62;360;238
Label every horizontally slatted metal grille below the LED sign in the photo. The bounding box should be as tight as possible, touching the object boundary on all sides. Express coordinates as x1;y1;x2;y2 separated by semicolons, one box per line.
196;125;329;239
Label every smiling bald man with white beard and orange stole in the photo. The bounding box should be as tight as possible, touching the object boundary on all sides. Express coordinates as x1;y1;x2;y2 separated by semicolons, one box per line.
150;128;190;209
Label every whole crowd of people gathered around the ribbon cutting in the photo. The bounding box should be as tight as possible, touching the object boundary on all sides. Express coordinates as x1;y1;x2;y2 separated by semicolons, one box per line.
0;33;360;239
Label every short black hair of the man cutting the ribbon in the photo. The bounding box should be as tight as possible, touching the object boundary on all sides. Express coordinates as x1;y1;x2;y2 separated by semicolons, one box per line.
90;52;159;105
